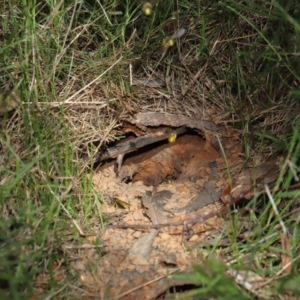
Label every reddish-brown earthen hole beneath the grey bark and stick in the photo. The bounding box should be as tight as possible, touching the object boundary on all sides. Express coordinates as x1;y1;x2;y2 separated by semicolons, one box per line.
119;131;219;187
